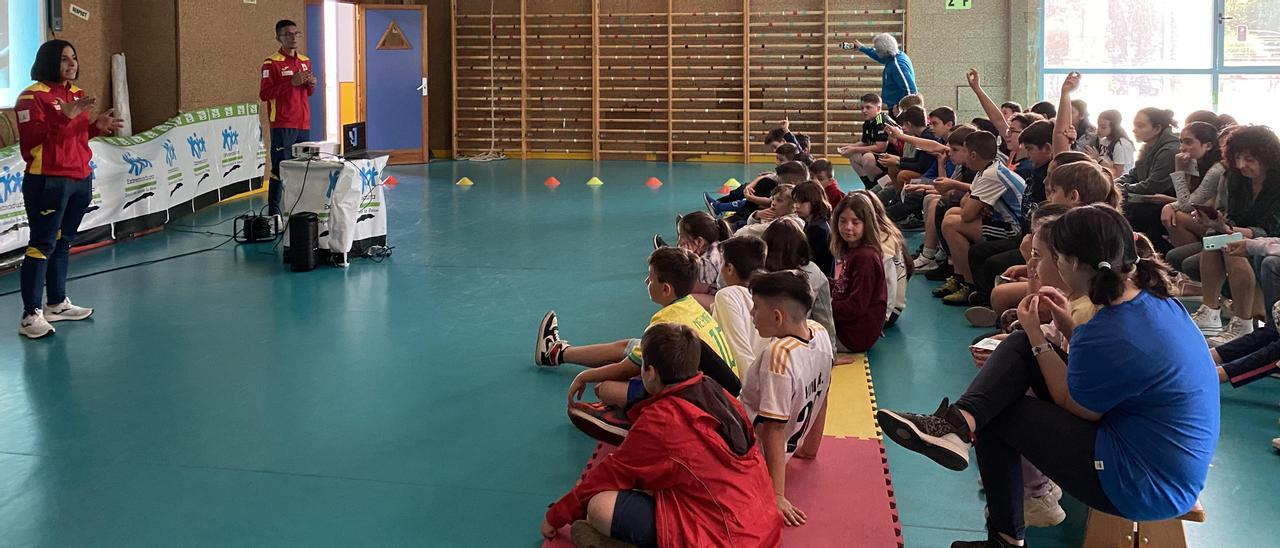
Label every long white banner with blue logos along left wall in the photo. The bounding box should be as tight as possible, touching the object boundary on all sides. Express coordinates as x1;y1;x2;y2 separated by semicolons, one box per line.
0;104;266;254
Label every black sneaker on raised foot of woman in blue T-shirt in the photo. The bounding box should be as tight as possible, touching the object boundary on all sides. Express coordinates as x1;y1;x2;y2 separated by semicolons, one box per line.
876;398;973;470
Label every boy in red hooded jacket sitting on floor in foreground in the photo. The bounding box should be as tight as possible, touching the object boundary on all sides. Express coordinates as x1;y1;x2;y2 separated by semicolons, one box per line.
541;324;782;548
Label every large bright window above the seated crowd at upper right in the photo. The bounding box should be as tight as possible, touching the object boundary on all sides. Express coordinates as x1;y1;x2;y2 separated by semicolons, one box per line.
1042;0;1280;128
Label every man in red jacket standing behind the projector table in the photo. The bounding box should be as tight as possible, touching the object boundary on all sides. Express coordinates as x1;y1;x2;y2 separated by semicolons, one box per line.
257;19;316;215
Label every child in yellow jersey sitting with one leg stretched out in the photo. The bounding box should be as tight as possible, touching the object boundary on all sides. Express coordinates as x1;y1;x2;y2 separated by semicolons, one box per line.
535;247;741;443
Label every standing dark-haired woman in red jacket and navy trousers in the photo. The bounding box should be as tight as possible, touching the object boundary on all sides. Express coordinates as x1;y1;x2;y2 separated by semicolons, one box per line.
14;40;122;338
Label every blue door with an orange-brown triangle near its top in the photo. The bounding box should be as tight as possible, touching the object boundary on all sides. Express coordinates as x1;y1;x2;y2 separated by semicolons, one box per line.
362;6;428;164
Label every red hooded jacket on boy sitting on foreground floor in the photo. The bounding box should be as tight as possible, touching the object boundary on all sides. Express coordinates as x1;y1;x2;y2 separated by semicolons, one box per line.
547;374;782;547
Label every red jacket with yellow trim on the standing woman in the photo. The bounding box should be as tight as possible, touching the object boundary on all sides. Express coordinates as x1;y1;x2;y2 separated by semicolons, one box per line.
14;82;101;179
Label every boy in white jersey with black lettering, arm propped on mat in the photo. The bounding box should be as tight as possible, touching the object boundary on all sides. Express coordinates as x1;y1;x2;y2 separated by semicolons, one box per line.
742;270;835;526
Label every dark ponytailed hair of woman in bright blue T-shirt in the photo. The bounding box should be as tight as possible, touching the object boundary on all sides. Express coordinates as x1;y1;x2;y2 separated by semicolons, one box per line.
1050;205;1170;305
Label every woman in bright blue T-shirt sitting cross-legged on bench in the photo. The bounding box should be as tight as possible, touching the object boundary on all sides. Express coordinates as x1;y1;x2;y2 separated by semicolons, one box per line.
877;205;1220;548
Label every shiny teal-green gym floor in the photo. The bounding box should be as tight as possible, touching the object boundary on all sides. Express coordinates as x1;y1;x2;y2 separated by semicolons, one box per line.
0;160;1280;547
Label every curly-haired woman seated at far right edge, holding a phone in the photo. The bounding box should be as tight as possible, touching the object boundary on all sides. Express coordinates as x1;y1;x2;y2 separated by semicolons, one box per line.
1184;125;1280;346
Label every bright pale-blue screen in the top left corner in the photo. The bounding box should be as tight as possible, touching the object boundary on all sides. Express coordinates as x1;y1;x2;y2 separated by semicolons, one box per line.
0;0;45;108
